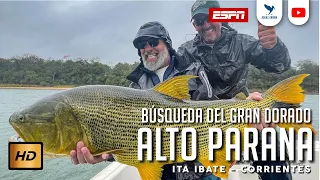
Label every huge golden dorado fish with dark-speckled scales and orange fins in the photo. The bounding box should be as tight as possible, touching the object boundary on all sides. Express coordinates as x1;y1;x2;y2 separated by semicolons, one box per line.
9;74;314;180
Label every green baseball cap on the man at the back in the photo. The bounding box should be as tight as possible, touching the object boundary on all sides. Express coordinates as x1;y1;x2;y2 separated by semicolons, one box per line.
191;0;220;20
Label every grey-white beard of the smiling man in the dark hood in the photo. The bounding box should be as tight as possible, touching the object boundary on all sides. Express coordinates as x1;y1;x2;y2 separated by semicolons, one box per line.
141;49;169;71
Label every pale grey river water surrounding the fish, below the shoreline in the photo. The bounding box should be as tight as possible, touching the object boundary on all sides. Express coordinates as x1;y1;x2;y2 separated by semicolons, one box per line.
0;89;319;180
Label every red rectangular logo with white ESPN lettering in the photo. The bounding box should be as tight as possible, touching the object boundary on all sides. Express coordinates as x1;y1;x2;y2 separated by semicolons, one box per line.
208;8;249;22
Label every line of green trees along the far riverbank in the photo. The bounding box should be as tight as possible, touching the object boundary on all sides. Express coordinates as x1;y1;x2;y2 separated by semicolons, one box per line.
0;55;319;93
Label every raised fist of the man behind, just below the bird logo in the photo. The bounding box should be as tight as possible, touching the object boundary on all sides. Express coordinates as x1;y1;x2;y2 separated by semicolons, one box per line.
258;22;277;49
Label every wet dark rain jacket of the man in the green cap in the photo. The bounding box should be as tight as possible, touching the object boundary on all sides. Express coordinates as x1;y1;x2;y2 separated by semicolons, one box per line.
177;25;291;99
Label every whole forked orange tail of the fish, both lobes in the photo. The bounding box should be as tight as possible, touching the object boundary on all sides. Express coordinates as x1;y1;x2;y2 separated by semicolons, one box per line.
264;74;317;134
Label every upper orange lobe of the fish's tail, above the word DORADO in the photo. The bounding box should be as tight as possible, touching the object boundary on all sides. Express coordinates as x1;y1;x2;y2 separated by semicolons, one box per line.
264;74;310;104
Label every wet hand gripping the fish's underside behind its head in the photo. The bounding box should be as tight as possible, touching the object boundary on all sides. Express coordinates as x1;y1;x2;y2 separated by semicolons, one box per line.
70;141;111;164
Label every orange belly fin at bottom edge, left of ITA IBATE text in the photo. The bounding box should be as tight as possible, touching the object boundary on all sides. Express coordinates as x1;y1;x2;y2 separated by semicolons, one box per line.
136;163;163;180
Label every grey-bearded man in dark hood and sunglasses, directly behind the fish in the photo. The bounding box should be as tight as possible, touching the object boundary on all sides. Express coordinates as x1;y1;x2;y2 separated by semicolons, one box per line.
127;21;217;100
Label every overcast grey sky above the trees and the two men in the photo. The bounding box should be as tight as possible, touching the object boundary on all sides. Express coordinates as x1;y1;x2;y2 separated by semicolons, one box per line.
0;0;319;65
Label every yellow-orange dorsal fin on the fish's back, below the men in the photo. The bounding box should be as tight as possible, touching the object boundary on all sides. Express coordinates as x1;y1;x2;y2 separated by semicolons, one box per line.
153;75;198;100
